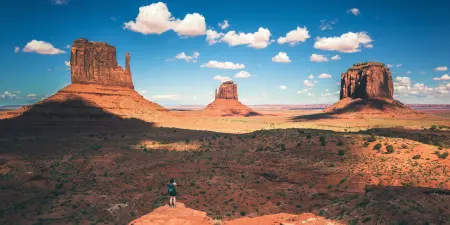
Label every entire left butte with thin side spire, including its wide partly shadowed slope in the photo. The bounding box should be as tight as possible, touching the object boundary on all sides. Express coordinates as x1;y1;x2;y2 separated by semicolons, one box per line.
2;39;168;123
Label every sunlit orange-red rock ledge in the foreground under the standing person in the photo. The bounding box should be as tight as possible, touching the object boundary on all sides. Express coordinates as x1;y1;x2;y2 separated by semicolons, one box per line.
128;203;343;225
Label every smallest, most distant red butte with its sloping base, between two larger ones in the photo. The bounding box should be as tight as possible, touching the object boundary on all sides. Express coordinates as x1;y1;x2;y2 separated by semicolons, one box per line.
199;81;259;116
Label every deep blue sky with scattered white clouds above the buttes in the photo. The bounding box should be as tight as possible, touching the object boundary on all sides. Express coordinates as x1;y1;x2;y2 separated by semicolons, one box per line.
0;0;450;105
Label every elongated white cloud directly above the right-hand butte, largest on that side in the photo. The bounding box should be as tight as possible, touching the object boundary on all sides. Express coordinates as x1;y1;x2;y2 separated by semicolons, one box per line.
314;32;373;53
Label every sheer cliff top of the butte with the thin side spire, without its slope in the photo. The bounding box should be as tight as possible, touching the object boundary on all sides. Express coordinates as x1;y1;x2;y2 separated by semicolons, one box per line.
70;38;134;88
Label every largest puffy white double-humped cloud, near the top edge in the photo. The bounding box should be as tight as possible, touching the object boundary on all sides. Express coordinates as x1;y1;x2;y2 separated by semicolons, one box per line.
124;2;206;36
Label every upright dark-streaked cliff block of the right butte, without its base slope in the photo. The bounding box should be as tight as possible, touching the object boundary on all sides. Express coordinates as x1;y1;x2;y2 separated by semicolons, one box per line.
340;62;394;99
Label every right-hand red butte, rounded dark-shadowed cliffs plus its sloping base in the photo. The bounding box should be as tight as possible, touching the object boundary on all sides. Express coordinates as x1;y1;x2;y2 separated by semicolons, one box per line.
324;62;422;117
